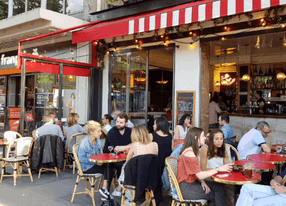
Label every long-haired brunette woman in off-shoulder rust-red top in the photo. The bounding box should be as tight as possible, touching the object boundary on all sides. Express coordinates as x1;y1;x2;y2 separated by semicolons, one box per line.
177;127;232;206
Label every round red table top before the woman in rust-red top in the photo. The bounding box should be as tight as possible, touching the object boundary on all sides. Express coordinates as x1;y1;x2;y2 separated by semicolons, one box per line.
212;172;261;185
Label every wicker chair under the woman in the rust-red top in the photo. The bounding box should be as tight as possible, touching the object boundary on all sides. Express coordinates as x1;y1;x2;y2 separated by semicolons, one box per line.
166;157;207;206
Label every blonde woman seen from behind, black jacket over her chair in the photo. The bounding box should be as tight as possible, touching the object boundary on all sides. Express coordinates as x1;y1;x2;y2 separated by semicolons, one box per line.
118;124;158;205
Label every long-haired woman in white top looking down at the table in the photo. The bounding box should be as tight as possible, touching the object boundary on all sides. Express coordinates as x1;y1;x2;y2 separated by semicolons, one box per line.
200;129;235;206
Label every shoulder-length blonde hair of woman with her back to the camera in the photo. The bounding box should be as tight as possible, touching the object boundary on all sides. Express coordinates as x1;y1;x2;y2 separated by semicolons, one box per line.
131;124;151;145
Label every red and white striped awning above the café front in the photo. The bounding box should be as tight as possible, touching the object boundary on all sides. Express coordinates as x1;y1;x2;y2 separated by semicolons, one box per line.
73;0;286;43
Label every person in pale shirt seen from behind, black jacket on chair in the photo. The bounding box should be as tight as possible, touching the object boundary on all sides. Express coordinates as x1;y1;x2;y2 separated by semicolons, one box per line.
35;114;64;140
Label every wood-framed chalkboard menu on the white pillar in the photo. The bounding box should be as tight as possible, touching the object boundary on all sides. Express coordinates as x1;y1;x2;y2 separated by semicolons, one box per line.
176;91;196;126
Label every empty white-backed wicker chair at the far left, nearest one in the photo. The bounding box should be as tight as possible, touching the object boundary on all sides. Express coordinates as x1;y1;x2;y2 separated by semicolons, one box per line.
1;137;33;186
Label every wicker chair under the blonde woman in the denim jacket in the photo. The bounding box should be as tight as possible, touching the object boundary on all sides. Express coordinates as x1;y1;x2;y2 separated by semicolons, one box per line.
71;144;103;206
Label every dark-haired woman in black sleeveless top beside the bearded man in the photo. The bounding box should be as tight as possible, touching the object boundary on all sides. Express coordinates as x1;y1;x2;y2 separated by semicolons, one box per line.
151;117;173;174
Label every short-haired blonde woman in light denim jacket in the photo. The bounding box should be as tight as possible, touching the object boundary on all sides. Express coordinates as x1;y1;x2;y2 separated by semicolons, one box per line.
78;121;105;174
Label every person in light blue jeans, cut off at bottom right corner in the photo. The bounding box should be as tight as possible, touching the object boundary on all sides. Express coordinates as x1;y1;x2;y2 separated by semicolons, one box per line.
236;169;286;206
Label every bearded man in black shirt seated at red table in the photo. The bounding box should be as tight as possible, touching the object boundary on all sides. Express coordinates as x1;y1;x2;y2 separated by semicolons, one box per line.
99;113;131;198
